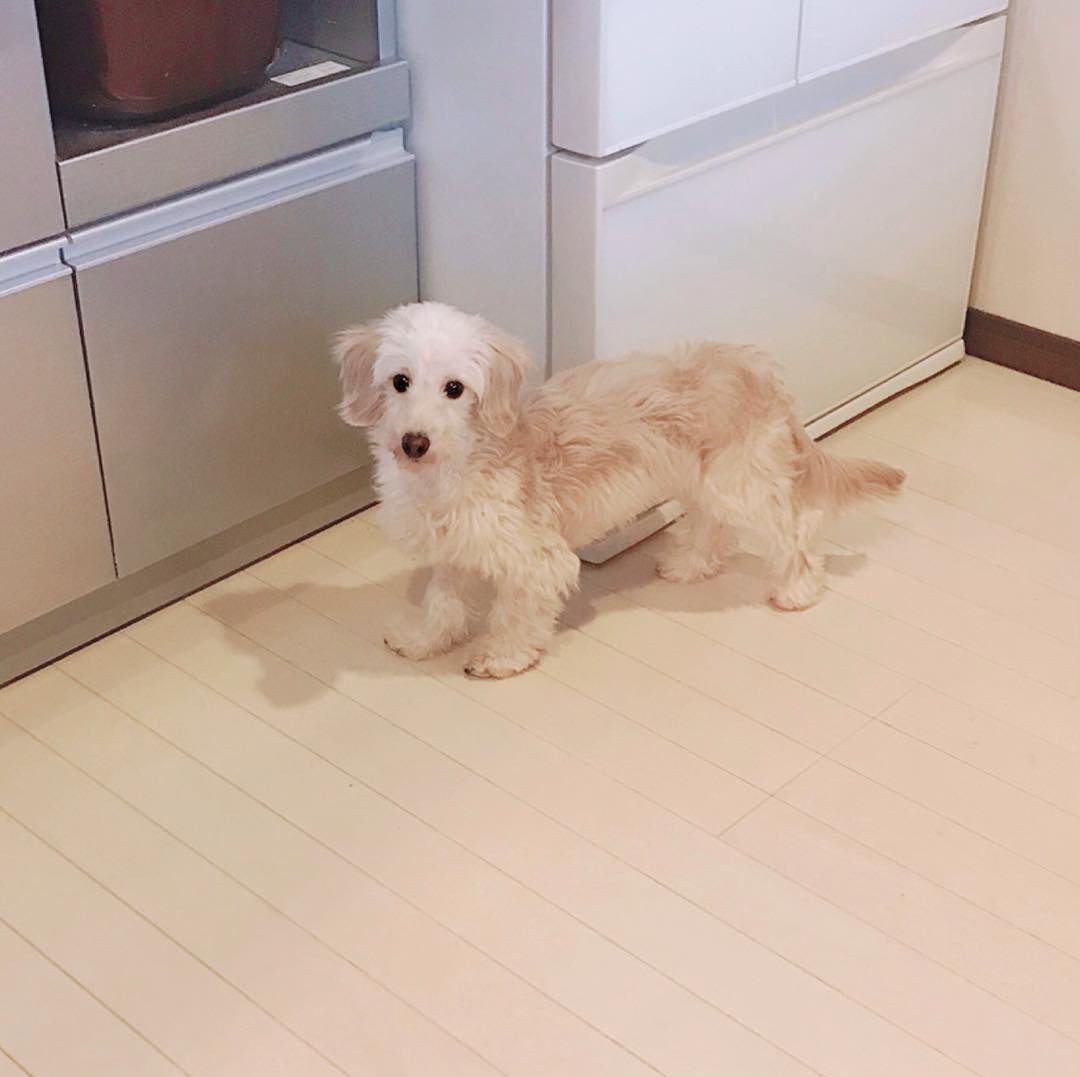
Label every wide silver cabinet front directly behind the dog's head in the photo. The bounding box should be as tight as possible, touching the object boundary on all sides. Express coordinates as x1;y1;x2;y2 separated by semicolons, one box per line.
73;153;416;576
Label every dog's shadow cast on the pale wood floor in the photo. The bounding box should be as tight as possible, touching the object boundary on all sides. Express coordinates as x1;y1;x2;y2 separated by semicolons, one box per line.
200;544;865;709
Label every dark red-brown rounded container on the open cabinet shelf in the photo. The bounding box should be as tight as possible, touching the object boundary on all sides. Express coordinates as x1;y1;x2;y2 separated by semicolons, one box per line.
38;0;280;120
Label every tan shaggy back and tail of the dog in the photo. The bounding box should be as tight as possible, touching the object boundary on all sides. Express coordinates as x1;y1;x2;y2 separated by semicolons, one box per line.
521;342;904;546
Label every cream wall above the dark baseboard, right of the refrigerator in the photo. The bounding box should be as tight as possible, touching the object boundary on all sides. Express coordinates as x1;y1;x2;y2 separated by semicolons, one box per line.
971;0;1080;340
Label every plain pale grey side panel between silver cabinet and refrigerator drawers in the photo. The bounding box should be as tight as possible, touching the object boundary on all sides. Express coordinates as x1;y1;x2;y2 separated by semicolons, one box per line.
397;0;548;373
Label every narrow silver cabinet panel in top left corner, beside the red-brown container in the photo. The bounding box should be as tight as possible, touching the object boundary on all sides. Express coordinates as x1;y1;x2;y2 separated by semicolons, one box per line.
0;0;64;252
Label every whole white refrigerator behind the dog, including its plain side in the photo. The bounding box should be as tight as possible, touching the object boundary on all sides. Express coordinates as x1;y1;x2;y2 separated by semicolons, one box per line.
399;0;1007;434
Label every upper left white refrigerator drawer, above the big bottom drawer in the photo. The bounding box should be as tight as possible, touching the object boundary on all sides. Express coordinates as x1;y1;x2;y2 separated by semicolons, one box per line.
552;0;799;157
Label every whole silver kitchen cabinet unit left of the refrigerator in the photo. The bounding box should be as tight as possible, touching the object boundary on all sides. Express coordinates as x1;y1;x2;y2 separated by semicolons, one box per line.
0;0;417;683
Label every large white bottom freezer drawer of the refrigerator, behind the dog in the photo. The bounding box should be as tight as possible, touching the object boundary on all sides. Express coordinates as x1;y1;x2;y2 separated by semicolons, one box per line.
552;19;1004;418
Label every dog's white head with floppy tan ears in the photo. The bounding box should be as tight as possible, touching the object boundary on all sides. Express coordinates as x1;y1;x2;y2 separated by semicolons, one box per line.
335;302;529;470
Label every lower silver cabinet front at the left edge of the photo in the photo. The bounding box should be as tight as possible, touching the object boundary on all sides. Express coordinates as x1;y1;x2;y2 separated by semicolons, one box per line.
0;259;114;634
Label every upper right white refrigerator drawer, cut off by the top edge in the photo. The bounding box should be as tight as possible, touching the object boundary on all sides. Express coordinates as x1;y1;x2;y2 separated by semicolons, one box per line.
799;0;1009;79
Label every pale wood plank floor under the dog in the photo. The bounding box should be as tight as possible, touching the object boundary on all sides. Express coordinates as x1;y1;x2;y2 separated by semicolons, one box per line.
0;361;1080;1077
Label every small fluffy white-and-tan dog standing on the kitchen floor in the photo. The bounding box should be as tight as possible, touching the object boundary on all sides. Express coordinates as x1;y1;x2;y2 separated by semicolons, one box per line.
336;302;904;677
